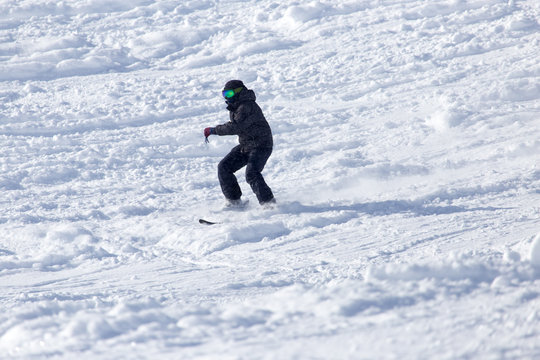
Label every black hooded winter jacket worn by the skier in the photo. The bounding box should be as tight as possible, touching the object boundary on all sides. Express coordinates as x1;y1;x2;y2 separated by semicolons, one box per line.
215;89;274;151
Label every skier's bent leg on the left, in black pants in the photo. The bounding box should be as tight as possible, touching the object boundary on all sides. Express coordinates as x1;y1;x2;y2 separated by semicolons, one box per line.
218;146;247;201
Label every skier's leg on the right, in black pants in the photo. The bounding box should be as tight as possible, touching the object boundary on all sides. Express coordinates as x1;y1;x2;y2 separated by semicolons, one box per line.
246;149;274;204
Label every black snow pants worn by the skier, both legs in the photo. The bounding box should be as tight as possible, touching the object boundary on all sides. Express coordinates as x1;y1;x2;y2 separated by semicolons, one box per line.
218;145;274;204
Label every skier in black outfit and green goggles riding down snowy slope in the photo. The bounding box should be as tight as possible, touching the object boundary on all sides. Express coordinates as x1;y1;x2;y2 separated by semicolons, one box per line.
204;80;275;206
